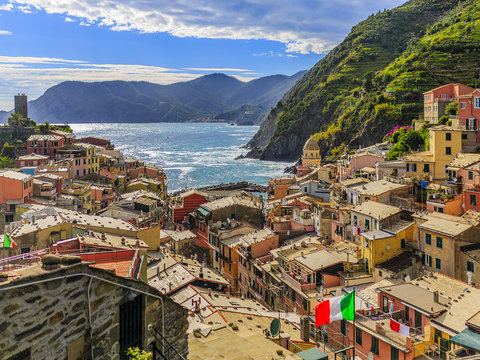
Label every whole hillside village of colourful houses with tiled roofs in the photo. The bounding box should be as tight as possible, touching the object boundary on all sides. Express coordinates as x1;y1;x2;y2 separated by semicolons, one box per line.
0;83;480;360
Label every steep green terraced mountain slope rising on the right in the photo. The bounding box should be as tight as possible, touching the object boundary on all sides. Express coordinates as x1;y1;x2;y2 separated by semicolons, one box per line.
248;0;480;160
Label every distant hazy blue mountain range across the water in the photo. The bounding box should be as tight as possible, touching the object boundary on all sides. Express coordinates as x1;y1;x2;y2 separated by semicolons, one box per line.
0;72;304;123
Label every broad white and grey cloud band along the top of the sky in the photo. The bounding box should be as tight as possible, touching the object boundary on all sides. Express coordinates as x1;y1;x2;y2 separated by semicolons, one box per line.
7;0;404;54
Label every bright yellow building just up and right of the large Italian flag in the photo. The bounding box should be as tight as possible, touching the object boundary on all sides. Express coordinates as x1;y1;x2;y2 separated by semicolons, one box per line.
361;222;414;274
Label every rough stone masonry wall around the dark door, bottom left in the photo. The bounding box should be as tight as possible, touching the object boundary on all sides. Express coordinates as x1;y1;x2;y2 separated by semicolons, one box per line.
0;264;188;360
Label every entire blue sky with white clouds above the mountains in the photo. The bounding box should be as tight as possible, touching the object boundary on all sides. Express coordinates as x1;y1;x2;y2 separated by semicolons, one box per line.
0;0;404;110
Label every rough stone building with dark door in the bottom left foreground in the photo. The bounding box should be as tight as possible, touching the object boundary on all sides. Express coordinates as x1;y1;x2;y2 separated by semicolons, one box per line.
0;255;188;360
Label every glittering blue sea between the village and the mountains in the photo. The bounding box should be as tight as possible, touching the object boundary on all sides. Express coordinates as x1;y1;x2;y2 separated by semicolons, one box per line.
71;123;291;192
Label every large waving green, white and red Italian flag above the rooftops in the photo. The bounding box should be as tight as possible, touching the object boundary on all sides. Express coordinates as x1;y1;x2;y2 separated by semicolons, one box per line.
315;292;355;327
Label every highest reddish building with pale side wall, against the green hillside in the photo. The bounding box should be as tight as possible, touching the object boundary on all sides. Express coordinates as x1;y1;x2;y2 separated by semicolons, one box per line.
423;83;474;124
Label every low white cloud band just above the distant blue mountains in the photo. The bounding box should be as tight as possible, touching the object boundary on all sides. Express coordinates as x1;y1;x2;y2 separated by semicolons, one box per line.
0;56;256;109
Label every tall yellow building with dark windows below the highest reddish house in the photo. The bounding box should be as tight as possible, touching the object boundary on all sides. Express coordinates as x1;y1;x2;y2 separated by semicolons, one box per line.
403;125;462;182
